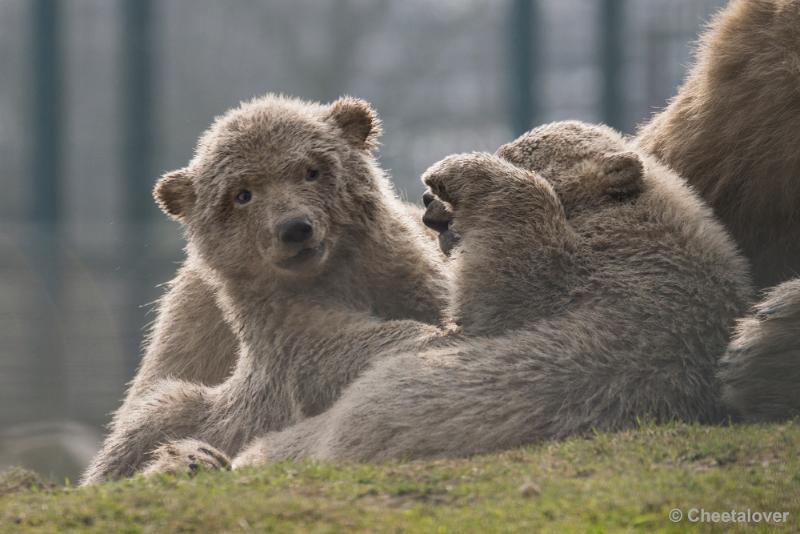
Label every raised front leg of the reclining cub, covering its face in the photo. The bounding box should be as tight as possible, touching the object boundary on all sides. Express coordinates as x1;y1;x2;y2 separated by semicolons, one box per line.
423;153;578;334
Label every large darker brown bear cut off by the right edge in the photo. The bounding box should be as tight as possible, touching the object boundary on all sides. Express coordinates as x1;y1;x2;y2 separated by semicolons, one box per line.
638;0;800;428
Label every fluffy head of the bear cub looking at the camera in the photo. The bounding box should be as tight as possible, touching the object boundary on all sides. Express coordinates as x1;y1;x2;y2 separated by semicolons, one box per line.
154;95;385;279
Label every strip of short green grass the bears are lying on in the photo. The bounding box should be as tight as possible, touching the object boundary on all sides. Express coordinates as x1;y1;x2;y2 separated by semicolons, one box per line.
0;422;800;533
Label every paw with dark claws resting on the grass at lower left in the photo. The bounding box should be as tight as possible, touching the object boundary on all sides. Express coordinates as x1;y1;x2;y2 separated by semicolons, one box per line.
143;439;231;476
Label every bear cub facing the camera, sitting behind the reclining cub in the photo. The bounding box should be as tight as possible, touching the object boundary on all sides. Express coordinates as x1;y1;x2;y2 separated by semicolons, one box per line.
85;96;449;482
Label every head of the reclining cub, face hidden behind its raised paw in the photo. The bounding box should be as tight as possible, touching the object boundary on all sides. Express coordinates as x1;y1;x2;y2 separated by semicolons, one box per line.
497;121;645;217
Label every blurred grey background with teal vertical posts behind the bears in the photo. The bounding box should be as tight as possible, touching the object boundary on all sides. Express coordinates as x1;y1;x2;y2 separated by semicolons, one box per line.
0;0;724;480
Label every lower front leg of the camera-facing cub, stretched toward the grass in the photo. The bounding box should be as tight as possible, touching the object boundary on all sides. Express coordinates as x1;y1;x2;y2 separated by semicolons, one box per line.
82;380;214;485
